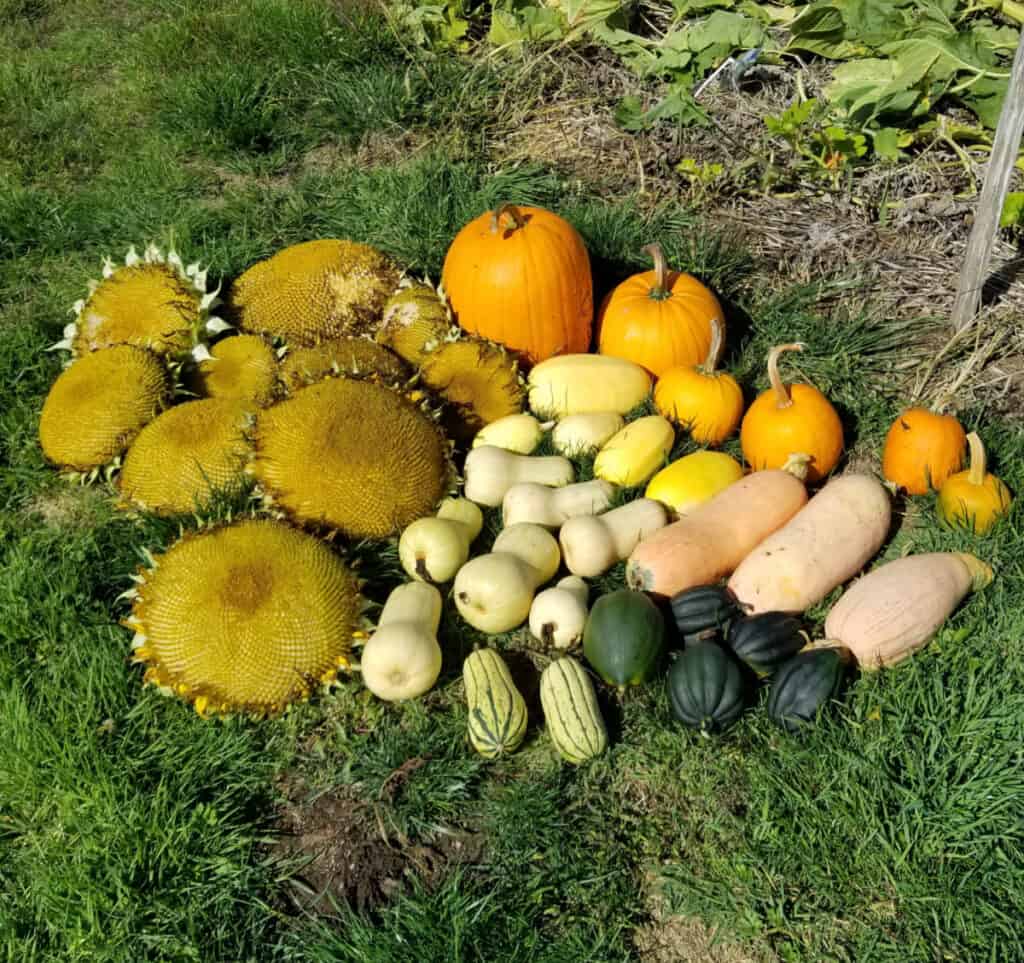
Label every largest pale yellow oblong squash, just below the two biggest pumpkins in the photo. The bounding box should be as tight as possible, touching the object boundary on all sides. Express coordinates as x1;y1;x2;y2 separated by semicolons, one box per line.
527;354;651;418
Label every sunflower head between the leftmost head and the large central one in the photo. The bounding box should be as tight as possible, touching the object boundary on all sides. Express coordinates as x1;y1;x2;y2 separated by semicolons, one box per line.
119;399;251;514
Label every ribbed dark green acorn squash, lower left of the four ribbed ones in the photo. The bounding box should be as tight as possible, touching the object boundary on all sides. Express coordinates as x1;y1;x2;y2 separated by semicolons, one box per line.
668;642;745;736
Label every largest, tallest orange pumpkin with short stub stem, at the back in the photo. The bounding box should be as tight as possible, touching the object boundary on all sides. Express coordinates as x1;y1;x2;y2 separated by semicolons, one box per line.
441;204;594;365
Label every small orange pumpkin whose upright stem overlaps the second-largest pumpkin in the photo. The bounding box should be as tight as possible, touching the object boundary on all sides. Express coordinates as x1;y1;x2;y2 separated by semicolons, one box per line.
654;318;743;445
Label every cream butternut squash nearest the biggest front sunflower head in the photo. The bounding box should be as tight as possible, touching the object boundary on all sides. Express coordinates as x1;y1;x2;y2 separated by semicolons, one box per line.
359;582;441;702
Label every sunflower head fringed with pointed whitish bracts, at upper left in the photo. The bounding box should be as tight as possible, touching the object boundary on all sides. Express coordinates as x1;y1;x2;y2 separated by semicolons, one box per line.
54;244;227;359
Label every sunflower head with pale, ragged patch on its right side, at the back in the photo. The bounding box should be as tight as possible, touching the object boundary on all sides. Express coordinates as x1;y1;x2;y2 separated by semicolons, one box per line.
228;240;398;345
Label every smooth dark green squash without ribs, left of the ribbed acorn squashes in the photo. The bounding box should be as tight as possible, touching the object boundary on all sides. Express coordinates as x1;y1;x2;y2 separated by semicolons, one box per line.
583;588;665;688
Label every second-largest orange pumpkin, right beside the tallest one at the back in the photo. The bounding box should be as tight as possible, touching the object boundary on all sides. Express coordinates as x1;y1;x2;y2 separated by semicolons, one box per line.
597;244;725;377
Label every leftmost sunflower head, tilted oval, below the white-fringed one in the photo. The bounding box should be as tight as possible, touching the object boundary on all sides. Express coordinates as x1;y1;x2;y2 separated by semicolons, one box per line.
39;345;171;471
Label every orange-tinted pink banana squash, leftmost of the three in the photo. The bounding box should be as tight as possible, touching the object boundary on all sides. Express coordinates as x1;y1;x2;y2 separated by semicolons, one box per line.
626;469;807;596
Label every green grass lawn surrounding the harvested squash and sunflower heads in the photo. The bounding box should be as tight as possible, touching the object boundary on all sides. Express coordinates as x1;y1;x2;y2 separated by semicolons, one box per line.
0;0;1024;963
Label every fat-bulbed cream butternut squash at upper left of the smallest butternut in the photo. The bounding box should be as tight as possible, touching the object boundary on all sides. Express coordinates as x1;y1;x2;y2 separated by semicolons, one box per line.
454;522;561;635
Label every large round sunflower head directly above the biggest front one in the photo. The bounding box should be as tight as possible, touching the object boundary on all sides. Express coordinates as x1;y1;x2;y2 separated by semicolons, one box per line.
252;378;450;538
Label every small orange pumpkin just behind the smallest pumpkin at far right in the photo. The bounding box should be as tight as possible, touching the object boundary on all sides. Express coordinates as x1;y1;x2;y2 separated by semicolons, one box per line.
882;408;967;495
